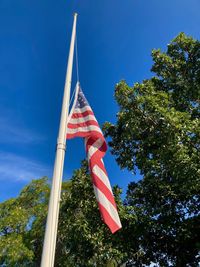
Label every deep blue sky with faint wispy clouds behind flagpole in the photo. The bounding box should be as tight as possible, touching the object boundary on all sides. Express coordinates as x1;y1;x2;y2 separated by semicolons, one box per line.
0;0;200;201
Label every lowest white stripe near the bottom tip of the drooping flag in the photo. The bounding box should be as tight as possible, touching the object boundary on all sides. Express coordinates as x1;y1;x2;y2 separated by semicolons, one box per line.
93;185;121;228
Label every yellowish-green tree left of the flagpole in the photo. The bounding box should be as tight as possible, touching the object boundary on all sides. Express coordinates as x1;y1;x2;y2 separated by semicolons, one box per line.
0;178;49;267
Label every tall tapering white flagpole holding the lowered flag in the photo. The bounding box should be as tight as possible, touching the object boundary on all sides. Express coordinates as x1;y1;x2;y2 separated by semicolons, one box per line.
41;13;77;267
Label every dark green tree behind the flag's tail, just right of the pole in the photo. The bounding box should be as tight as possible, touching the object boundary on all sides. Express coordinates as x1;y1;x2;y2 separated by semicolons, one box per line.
56;161;125;267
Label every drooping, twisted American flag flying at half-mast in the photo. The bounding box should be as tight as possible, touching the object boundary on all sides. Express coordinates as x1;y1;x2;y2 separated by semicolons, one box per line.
67;83;122;233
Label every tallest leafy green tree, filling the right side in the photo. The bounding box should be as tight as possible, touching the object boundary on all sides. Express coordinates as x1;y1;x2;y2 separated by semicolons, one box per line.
104;33;200;267
